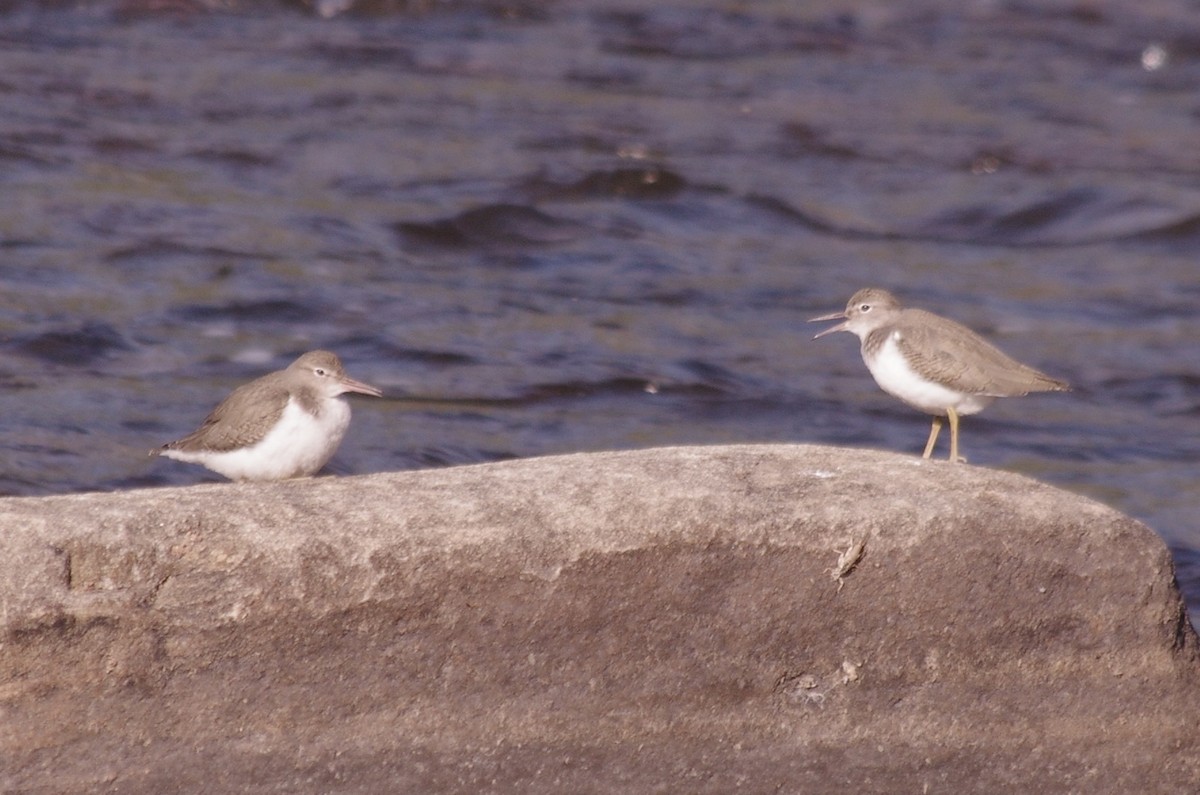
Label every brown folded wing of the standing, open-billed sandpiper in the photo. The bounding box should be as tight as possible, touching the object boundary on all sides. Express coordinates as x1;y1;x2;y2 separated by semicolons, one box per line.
898;309;1070;398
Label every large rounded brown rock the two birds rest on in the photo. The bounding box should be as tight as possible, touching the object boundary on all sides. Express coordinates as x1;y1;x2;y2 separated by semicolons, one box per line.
0;446;1200;794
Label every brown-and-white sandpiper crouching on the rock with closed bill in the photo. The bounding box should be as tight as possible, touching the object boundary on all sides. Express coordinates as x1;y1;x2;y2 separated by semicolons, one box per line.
150;351;383;480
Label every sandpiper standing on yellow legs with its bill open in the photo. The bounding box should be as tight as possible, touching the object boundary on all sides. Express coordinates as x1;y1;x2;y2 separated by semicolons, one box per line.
809;287;1070;461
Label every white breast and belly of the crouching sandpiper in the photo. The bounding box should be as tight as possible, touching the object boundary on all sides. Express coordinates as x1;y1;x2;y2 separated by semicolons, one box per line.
163;399;350;480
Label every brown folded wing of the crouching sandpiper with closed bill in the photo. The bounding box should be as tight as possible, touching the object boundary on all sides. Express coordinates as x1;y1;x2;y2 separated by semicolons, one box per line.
163;372;288;452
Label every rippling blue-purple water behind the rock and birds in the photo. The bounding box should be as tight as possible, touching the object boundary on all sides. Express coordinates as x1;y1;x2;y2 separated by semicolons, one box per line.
0;0;1200;610
